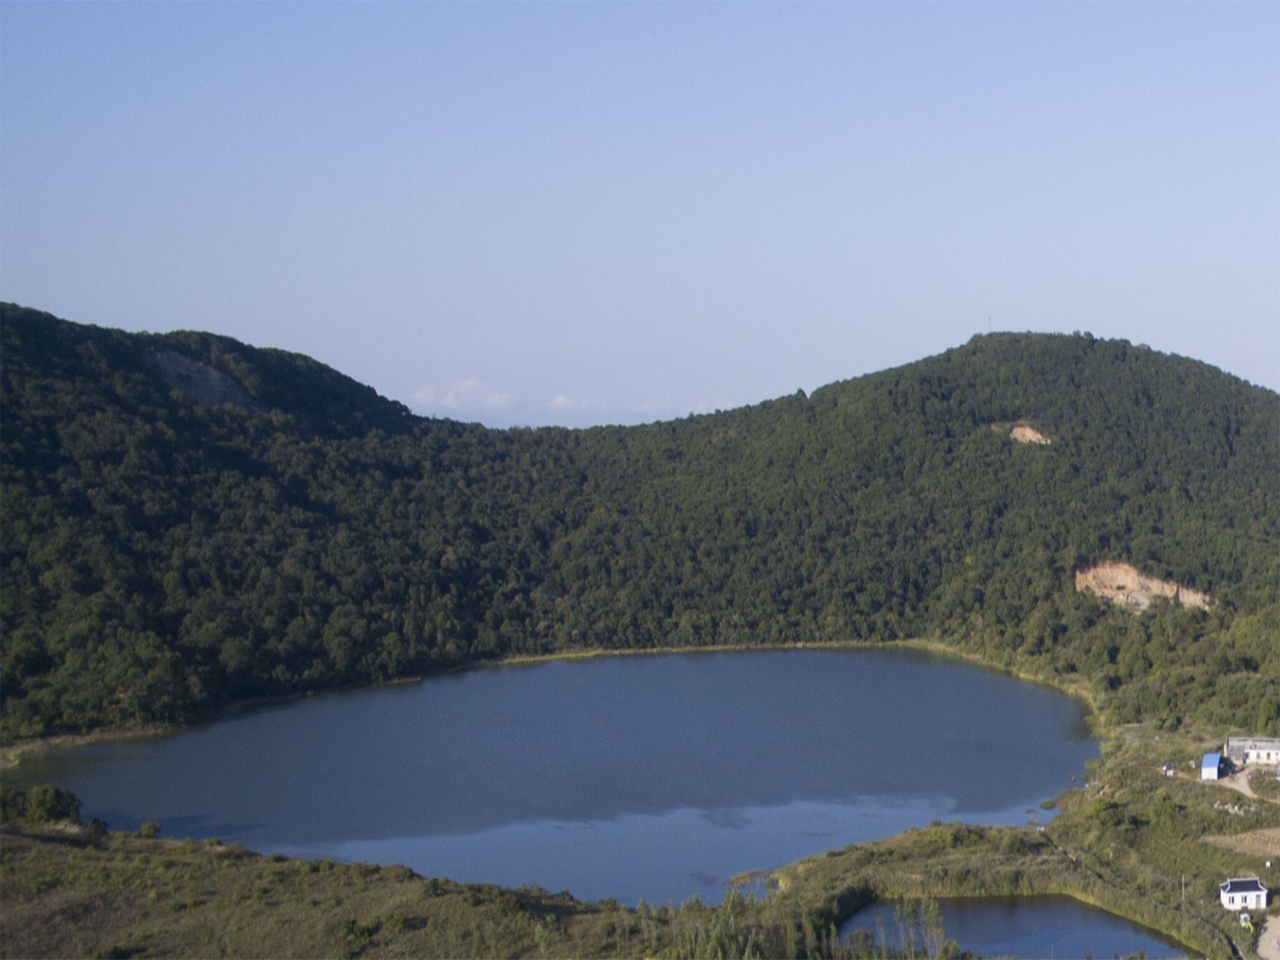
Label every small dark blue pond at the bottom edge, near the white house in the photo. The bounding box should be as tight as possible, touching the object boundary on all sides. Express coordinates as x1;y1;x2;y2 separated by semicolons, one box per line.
840;896;1187;960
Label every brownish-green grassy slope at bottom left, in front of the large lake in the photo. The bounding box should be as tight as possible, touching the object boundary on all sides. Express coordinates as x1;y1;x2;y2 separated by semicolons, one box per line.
0;826;669;960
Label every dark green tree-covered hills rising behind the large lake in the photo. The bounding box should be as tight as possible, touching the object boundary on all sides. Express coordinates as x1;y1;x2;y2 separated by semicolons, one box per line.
0;306;1280;739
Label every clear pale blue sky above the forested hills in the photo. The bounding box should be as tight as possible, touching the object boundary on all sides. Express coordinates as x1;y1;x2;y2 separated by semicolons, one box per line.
0;0;1280;425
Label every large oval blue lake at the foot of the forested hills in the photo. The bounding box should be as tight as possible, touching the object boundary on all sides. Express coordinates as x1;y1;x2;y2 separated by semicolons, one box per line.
5;649;1098;904
